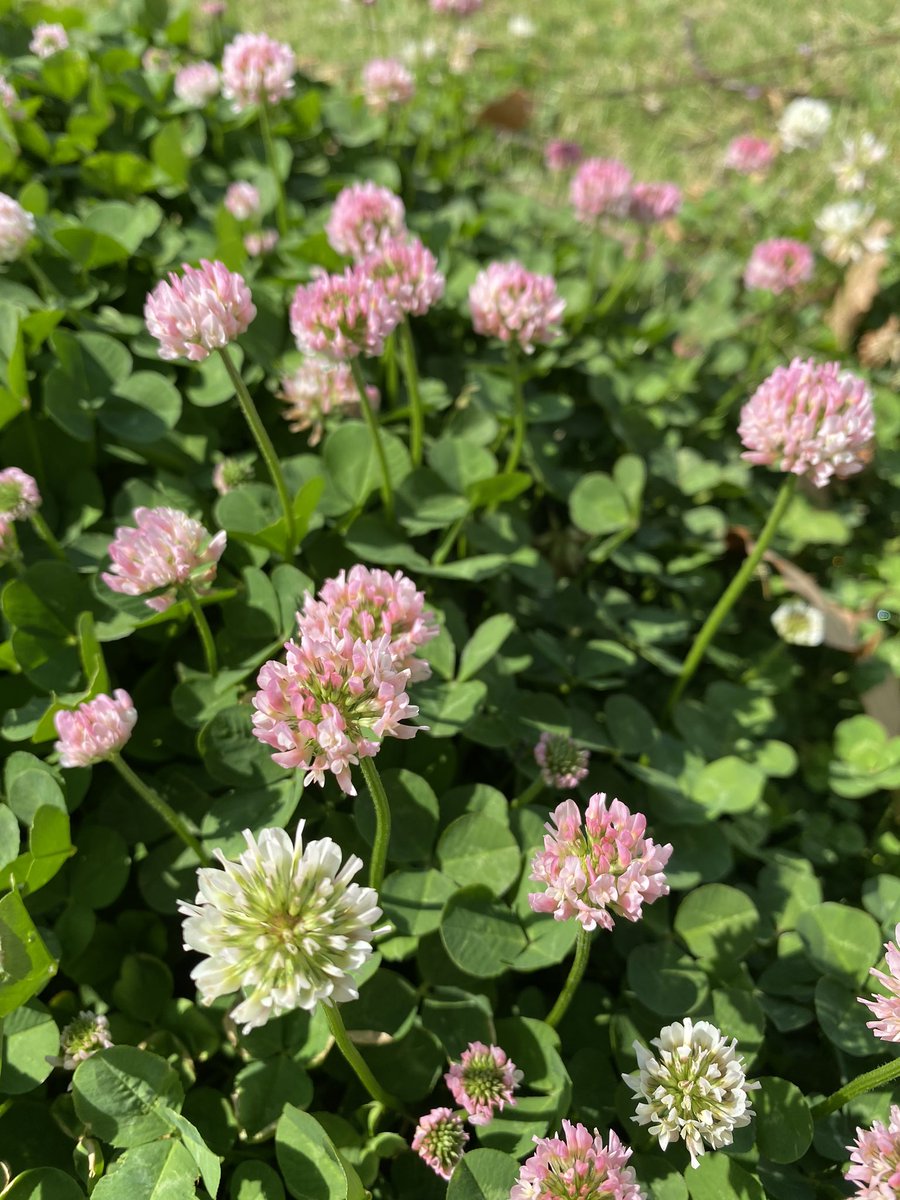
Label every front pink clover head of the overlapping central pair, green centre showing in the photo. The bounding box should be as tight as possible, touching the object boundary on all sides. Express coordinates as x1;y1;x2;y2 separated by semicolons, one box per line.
253;634;420;796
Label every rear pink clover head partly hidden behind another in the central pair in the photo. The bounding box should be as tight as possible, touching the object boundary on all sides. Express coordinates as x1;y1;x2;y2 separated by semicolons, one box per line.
296;563;438;682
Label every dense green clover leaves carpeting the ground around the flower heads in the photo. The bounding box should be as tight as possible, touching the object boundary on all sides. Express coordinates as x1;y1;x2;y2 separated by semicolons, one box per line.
0;2;900;1200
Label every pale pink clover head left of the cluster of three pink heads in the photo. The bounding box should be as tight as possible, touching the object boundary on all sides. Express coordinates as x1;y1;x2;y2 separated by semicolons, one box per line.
144;258;257;362
